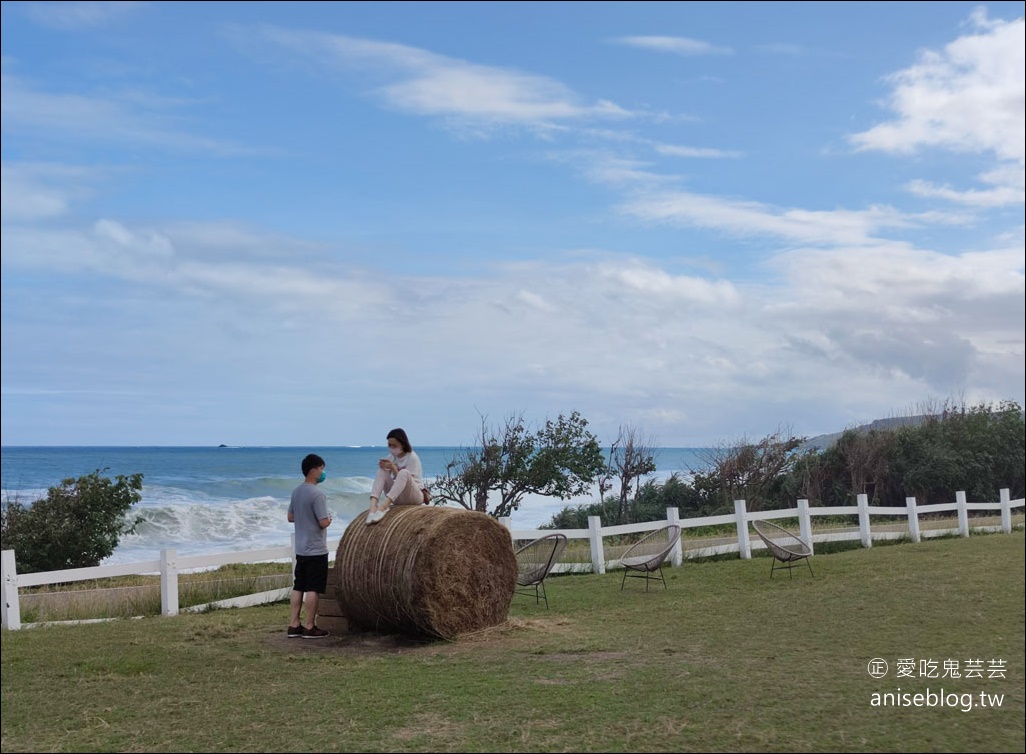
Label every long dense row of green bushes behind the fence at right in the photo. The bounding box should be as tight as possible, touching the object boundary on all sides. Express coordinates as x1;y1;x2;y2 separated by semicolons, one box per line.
542;401;1026;528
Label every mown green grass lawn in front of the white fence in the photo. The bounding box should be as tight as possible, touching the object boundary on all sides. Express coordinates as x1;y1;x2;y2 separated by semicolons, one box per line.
0;530;1026;752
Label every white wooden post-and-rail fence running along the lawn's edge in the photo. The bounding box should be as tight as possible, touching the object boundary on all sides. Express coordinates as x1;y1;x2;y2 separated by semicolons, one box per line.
0;489;1026;631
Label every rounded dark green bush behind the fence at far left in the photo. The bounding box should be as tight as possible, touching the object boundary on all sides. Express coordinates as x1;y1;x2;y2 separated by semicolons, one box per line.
0;469;143;573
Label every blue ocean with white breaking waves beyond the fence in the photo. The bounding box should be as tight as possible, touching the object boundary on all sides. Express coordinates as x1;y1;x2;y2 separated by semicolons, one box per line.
0;445;701;563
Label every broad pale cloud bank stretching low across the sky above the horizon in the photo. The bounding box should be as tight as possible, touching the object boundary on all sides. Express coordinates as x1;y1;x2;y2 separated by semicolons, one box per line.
3;203;1026;444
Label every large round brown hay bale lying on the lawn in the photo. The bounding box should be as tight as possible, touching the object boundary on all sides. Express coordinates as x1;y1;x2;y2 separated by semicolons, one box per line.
334;506;517;639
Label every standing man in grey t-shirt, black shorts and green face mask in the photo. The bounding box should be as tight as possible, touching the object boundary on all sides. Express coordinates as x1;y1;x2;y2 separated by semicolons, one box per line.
286;453;331;639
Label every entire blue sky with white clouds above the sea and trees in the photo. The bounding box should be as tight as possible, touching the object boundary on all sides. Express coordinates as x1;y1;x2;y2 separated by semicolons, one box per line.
0;2;1026;446
